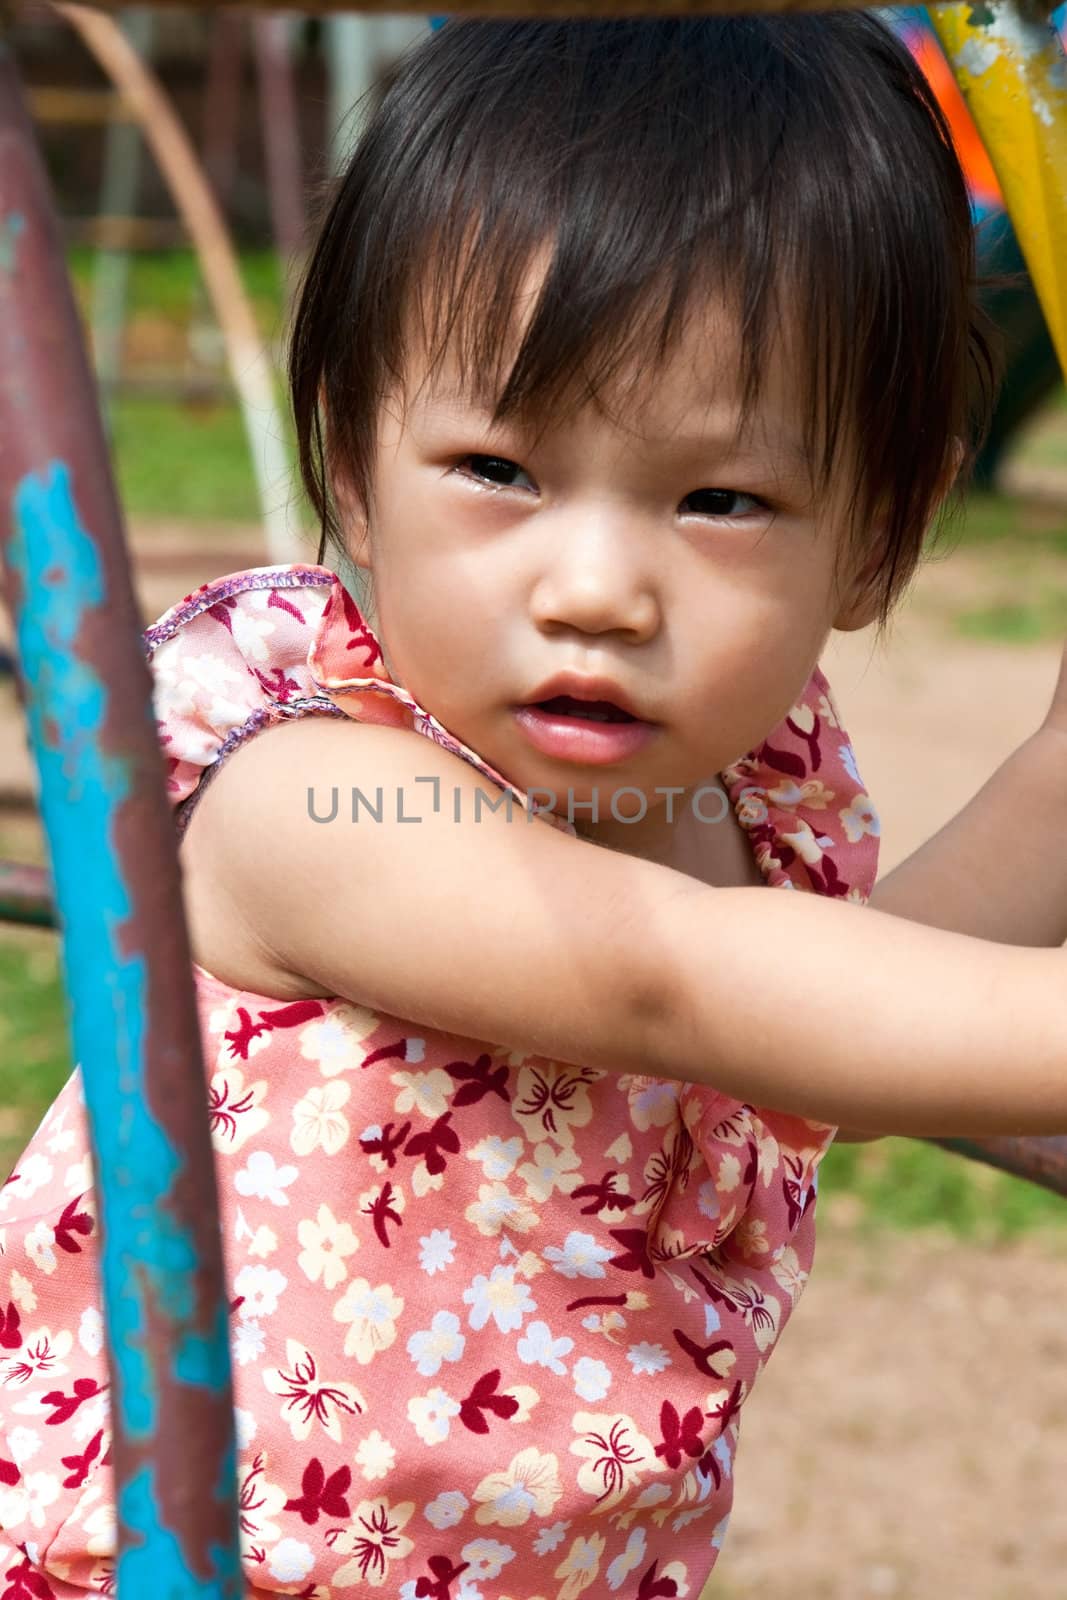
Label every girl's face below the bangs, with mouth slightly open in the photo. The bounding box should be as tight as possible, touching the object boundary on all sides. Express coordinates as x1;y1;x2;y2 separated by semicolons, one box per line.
349;278;877;858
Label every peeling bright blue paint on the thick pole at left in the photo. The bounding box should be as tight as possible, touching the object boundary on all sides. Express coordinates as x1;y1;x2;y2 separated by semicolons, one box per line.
10;461;240;1600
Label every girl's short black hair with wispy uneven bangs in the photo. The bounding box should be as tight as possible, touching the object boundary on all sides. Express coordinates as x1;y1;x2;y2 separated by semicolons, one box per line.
290;11;998;626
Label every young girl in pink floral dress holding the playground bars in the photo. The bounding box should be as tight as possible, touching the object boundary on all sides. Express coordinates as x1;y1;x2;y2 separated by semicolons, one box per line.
0;14;1067;1600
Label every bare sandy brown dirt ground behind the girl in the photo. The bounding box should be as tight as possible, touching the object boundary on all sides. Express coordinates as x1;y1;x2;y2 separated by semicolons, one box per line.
0;528;1067;1600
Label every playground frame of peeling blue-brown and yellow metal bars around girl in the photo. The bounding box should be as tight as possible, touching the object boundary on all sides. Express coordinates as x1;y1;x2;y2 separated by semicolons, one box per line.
0;0;1067;1600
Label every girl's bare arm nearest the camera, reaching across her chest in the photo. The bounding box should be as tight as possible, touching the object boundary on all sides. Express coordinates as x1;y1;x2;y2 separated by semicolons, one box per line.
192;718;1067;1134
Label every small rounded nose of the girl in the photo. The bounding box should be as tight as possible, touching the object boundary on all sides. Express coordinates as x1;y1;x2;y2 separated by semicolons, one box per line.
531;517;661;643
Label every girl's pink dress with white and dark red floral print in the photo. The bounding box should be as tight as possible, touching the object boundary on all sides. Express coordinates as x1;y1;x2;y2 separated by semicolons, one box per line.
0;565;878;1600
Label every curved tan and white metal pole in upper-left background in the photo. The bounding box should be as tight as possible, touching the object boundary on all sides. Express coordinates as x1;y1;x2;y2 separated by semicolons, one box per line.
54;3;307;565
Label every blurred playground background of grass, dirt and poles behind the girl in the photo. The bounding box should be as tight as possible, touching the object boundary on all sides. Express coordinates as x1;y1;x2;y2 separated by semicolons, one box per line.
0;5;1067;1600
